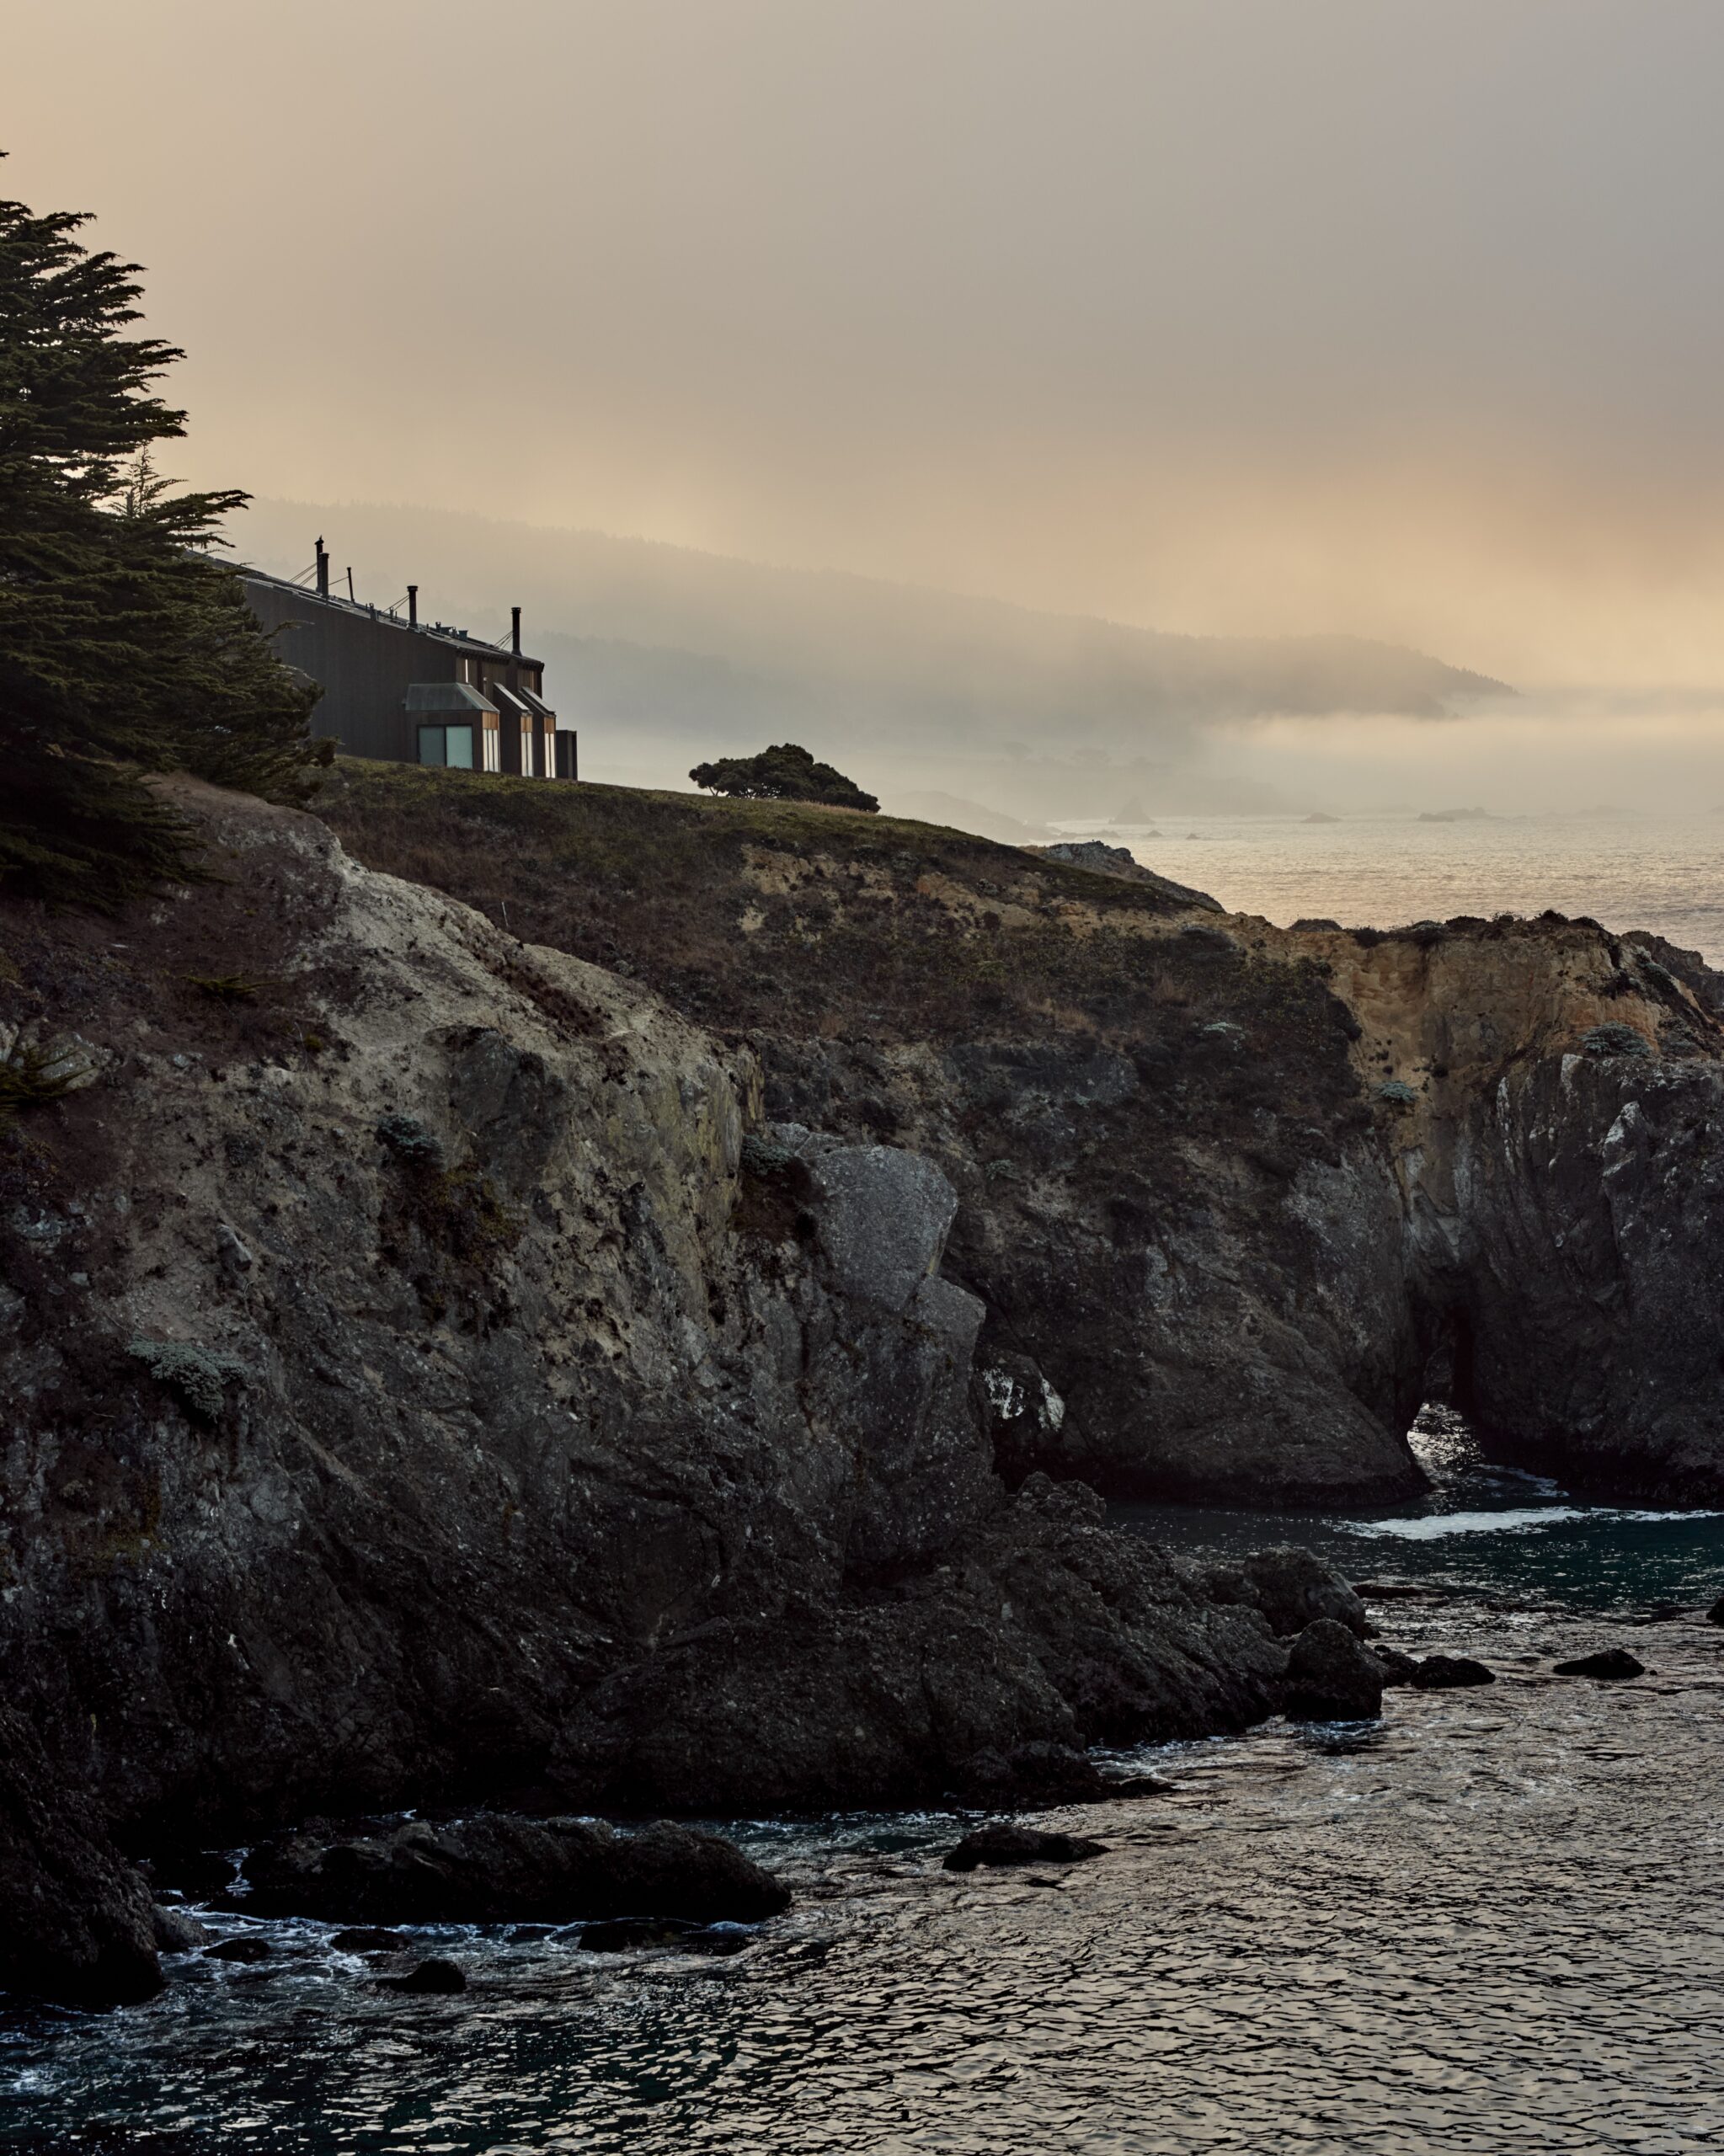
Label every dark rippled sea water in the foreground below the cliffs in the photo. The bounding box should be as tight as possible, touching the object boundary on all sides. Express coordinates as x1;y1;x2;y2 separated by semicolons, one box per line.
13;1412;1724;2156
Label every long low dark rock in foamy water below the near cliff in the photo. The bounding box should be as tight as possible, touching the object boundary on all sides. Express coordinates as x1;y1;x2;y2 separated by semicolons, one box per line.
246;1813;791;1925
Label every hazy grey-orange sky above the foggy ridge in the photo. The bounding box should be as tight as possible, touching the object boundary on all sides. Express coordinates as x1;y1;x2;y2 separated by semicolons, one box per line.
0;0;1724;686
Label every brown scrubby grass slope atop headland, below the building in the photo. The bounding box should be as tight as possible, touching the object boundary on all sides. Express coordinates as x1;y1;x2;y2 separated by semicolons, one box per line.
319;759;1349;1106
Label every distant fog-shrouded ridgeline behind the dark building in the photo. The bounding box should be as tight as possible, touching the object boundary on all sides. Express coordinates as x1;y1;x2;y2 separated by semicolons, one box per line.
246;500;1504;784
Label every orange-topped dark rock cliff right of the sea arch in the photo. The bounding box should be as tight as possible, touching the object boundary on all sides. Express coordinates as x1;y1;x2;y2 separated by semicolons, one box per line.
1312;916;1724;1502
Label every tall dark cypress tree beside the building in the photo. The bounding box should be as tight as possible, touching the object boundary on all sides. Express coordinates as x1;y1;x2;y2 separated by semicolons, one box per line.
0;159;329;910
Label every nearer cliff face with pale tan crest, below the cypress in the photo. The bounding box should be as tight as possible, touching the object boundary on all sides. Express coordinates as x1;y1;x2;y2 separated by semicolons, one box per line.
0;785;1284;1990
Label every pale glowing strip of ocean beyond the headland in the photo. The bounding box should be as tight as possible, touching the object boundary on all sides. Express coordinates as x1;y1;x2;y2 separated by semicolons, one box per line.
1058;811;1724;966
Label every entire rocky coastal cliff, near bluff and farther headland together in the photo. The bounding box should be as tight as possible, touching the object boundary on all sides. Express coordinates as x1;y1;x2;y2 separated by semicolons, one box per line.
0;770;1724;2001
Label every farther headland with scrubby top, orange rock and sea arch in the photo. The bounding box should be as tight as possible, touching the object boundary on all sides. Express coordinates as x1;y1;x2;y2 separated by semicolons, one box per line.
325;766;1724;1505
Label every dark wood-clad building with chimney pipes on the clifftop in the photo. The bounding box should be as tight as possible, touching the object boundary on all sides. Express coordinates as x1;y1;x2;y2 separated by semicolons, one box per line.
239;539;578;778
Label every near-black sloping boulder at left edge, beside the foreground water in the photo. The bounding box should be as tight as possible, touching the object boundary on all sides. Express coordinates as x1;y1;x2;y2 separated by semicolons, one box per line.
0;1708;162;2007
